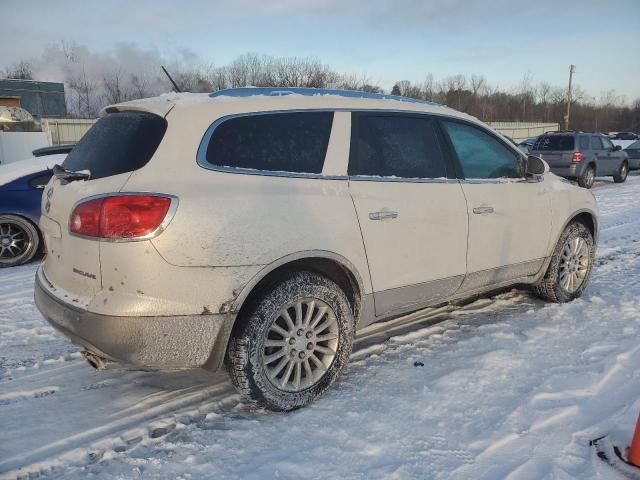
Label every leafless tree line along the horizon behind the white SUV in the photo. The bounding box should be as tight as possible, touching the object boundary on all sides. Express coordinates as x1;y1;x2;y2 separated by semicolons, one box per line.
4;53;640;131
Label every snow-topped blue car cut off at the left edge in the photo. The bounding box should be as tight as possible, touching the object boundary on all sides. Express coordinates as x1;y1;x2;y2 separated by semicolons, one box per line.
0;146;73;268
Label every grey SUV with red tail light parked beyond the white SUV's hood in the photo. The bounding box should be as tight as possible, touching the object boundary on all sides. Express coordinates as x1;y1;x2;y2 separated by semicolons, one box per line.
531;131;629;188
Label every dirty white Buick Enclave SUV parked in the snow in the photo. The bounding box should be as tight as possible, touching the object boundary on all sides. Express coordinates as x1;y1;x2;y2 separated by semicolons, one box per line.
35;88;598;410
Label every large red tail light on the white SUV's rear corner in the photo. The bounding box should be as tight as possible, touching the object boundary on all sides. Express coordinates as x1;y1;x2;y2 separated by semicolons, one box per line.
69;195;175;239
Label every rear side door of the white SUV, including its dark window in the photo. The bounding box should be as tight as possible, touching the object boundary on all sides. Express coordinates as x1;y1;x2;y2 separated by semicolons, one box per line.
349;112;467;316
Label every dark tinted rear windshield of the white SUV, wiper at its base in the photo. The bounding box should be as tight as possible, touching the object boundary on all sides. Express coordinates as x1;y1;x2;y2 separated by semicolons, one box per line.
62;112;167;180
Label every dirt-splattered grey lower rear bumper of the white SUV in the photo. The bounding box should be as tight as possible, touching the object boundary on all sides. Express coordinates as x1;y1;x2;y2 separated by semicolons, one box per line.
34;267;233;370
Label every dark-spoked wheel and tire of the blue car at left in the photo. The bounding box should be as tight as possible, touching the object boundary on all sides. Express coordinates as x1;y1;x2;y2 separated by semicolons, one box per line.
0;215;40;268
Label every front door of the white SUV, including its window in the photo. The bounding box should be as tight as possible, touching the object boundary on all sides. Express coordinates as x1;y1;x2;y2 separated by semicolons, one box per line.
441;120;552;291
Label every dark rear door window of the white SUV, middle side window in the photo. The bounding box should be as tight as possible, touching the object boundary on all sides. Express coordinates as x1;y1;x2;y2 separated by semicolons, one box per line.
349;113;447;178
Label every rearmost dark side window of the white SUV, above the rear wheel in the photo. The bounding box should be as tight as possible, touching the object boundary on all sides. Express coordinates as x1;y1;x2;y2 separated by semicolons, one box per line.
207;112;333;173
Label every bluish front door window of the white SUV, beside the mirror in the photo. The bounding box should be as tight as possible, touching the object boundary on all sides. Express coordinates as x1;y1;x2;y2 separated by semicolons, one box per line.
442;121;522;178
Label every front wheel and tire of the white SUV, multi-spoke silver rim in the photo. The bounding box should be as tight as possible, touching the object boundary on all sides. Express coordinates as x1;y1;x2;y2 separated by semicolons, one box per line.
534;222;596;303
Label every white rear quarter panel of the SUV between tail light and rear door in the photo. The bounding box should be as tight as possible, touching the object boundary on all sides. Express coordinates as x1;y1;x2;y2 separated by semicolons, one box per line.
119;103;371;293
